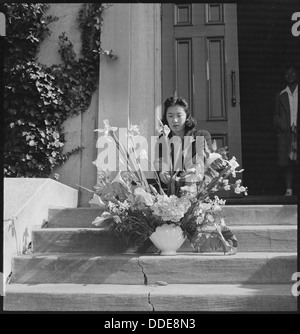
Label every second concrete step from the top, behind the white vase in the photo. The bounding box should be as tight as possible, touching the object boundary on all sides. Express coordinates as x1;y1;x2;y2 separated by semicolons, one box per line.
32;225;297;254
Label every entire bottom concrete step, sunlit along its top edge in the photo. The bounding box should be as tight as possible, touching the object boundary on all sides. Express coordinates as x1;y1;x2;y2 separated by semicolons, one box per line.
3;284;297;312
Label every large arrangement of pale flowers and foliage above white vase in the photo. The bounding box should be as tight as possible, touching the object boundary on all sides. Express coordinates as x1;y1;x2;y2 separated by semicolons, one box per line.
92;120;247;251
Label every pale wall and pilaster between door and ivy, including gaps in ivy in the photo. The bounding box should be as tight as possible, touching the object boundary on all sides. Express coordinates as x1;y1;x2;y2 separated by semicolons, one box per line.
39;3;161;206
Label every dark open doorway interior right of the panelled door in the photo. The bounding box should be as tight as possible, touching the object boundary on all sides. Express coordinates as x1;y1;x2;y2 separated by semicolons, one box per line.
237;0;300;195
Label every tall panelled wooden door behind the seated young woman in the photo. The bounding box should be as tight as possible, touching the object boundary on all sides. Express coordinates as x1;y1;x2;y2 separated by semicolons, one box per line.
162;3;242;170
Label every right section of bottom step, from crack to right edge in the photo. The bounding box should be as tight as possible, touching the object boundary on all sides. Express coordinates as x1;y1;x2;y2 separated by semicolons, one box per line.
150;284;297;312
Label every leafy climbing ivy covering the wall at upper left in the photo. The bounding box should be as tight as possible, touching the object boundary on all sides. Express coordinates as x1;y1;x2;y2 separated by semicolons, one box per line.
0;3;117;177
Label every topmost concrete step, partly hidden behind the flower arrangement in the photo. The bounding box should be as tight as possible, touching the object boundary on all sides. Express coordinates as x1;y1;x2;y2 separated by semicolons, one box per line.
47;205;297;228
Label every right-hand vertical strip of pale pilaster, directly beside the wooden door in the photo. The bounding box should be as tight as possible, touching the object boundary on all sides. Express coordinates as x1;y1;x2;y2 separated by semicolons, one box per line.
129;4;161;140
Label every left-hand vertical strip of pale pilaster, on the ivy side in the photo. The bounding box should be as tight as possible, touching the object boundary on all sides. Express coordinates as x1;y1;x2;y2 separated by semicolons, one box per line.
98;4;131;128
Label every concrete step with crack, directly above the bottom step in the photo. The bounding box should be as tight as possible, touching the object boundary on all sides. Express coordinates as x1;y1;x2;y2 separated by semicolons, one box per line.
11;253;297;285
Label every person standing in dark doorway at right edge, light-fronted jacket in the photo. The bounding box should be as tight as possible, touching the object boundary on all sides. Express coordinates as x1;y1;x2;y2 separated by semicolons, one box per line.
273;66;299;196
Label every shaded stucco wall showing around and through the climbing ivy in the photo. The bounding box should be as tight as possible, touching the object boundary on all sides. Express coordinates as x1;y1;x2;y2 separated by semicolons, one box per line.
38;3;98;206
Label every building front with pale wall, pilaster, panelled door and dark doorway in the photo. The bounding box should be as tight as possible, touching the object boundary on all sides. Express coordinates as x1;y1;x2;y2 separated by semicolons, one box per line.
39;0;299;206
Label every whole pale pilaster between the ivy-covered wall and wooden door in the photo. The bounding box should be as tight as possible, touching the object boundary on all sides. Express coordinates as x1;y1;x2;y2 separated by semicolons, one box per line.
98;3;161;177
